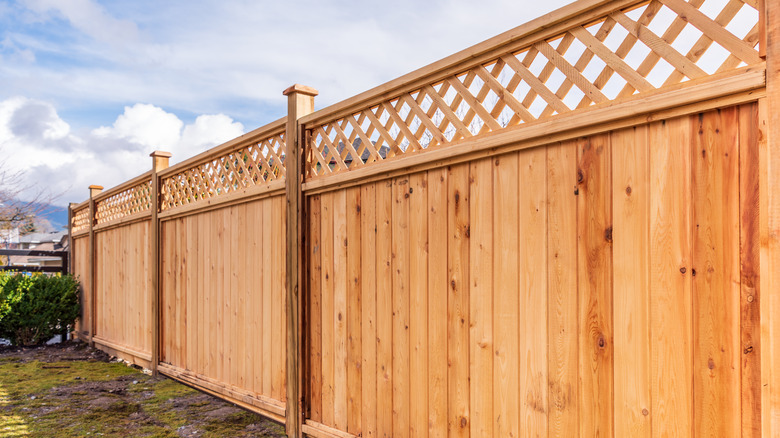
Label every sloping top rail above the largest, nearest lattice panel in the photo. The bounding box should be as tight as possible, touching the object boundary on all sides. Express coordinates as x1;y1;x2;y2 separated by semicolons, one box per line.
301;0;645;128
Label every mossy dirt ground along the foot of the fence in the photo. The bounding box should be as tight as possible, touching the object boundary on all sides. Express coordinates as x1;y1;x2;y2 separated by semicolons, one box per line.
0;342;285;438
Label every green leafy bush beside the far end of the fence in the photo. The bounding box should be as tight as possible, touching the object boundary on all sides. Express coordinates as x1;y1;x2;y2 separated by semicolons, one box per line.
0;273;79;346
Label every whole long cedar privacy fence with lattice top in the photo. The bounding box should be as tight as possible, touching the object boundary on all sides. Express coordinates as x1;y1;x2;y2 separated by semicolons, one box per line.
71;0;780;437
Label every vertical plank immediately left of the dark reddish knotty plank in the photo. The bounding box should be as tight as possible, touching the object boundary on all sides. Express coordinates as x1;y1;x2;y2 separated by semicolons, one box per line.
548;141;587;437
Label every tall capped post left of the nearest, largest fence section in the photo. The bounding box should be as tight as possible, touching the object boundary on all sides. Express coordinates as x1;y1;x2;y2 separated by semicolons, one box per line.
284;84;318;438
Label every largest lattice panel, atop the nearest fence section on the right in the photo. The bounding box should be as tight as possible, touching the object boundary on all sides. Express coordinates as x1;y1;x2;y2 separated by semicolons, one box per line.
306;0;762;179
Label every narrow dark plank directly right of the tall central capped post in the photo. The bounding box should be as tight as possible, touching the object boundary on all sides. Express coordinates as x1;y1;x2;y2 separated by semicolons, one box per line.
307;195;322;422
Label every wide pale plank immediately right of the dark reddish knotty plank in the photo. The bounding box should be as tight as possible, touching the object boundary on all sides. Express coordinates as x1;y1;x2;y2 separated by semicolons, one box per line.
612;126;651;437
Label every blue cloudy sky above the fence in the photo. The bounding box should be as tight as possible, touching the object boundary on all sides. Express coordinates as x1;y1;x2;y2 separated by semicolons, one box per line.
0;0;580;205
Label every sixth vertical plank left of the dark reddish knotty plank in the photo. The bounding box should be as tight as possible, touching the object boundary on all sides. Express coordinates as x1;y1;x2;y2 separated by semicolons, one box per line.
428;169;450;438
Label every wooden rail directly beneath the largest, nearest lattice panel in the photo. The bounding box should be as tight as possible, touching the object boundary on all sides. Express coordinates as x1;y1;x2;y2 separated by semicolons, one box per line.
303;64;766;195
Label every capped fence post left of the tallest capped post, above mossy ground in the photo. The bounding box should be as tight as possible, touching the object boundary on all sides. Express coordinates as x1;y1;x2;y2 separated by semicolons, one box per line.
149;151;171;376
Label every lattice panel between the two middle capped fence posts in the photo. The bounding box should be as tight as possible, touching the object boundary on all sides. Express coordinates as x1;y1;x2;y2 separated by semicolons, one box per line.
161;132;286;210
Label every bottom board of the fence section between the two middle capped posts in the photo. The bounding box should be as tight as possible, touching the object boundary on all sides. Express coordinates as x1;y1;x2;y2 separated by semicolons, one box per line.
157;363;286;423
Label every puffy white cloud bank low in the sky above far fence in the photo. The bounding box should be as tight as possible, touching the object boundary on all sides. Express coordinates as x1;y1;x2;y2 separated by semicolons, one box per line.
0;97;244;205
